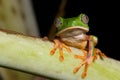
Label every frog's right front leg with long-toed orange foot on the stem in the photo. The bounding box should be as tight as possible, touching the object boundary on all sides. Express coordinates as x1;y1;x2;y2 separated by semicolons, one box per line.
73;36;105;78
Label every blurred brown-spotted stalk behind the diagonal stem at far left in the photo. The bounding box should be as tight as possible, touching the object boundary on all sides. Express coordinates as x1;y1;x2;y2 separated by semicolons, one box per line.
0;0;38;80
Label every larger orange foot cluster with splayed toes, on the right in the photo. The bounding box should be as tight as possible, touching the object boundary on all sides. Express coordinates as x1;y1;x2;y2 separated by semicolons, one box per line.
73;48;106;78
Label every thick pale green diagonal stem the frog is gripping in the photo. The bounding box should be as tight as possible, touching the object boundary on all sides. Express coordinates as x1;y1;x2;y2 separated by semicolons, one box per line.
0;31;120;80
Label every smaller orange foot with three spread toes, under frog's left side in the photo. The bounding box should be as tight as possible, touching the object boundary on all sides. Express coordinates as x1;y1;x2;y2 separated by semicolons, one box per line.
50;39;71;62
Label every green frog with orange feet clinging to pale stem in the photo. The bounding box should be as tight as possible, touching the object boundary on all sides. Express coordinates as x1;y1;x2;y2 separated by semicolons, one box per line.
50;13;105;78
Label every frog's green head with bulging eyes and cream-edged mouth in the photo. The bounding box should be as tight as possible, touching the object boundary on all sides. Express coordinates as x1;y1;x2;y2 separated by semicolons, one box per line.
55;14;89;37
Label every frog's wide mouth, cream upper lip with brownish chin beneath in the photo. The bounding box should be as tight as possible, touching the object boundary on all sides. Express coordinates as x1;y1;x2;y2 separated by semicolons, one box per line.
56;26;89;37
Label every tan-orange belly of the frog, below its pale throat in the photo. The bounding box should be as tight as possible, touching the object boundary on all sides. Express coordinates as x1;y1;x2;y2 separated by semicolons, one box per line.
61;37;87;49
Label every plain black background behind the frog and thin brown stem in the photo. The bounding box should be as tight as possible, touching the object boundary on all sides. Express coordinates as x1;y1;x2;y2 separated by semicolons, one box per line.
31;0;120;60
